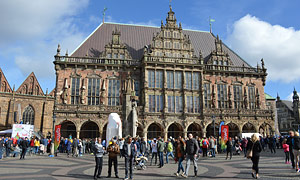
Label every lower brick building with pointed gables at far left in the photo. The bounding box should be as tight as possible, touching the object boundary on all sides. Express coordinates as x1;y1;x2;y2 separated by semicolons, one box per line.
0;69;54;135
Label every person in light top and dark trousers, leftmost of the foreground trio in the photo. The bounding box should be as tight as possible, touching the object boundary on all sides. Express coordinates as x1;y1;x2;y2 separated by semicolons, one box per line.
94;137;104;179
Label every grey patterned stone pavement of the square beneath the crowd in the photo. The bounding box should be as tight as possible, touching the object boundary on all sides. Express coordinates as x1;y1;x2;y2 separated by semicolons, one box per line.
0;149;300;180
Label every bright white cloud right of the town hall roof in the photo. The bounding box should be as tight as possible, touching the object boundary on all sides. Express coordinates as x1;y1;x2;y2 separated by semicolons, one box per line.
226;15;300;83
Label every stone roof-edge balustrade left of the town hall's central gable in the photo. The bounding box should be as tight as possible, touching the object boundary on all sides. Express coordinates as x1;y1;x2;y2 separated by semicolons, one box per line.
55;56;140;65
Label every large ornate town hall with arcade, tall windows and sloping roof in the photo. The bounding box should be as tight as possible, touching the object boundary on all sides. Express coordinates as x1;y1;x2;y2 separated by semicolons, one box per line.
54;7;274;138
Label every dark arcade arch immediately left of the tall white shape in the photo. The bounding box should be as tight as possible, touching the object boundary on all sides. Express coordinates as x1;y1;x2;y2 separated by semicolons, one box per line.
79;121;100;138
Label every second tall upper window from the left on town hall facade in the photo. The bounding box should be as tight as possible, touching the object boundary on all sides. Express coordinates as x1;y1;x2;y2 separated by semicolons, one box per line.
88;78;100;105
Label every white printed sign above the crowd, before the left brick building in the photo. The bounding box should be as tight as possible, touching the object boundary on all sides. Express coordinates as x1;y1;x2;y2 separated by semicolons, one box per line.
11;124;34;139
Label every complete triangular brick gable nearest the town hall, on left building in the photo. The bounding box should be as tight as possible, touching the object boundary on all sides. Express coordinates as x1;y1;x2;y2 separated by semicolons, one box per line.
17;72;45;96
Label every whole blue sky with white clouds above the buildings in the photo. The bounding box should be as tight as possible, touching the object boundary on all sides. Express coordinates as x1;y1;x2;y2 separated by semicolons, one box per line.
0;0;300;99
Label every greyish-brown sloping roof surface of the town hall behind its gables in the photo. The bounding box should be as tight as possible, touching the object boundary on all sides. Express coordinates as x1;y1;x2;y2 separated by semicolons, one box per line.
71;23;250;67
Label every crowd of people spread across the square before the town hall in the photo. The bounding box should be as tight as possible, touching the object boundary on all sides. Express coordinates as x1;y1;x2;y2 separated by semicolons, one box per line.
0;131;300;179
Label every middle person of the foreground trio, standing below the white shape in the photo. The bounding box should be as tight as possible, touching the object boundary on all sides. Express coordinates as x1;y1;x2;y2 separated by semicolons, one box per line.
107;138;120;178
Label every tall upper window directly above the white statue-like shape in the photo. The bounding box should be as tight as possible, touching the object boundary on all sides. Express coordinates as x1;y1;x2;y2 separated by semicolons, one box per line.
108;79;120;106
